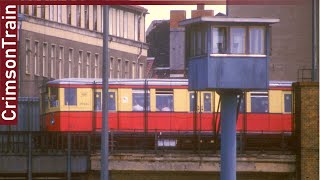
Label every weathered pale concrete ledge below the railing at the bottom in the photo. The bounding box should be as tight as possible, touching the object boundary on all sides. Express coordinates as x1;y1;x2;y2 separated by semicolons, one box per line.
88;153;295;180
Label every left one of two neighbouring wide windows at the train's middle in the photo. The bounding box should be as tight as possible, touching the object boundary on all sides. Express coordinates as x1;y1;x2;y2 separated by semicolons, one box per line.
132;89;150;111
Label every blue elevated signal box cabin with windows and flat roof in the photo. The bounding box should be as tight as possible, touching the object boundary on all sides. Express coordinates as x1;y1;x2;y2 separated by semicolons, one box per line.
179;16;279;91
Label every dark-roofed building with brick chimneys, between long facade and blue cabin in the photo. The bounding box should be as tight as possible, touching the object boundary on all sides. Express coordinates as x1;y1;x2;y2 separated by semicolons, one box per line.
146;5;214;79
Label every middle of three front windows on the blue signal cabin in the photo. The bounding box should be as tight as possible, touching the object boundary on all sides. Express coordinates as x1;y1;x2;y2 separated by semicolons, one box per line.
230;27;246;54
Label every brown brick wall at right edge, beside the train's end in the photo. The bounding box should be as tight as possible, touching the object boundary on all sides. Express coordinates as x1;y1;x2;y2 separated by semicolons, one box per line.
293;82;319;179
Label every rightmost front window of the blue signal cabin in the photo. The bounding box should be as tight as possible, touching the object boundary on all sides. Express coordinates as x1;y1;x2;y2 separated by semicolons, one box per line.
249;27;265;54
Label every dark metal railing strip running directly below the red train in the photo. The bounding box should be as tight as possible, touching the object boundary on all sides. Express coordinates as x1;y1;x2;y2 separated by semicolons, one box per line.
0;131;295;155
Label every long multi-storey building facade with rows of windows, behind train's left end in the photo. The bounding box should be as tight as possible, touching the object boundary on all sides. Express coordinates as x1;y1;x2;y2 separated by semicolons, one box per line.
19;5;148;97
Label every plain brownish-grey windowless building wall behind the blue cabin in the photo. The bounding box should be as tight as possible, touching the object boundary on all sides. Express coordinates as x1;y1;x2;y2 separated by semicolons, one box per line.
227;0;319;81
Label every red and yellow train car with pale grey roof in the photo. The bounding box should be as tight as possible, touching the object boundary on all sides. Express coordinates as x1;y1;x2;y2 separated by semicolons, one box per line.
41;78;293;133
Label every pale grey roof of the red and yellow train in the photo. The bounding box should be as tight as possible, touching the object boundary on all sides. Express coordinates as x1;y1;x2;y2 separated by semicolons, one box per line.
47;78;293;87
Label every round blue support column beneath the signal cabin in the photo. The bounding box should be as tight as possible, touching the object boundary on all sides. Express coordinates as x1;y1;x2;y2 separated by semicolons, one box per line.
220;93;237;180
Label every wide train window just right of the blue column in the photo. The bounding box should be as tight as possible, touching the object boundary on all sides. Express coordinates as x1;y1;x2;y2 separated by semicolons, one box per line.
251;93;269;113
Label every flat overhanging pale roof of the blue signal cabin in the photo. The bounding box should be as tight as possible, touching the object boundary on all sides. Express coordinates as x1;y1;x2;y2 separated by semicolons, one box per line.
179;16;280;26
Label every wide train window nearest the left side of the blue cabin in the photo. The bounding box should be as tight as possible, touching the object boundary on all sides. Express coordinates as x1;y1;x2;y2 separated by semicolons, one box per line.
156;89;173;111
